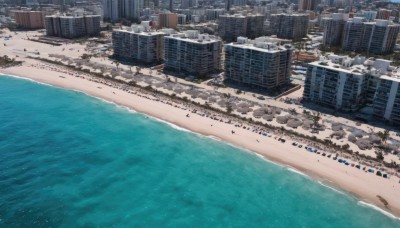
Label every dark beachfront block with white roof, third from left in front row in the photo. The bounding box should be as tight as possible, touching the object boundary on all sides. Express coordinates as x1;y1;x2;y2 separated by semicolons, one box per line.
225;37;293;90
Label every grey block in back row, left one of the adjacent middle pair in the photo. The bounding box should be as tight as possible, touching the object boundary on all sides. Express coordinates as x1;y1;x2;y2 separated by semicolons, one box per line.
218;14;265;42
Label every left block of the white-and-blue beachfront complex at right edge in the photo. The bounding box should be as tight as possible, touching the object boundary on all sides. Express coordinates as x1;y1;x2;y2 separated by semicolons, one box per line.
303;55;368;112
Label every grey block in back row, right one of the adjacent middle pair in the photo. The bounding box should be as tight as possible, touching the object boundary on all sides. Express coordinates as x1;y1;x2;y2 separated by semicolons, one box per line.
270;13;309;40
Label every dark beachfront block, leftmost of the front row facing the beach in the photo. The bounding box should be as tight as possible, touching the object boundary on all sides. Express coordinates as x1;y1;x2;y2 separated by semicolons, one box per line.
112;21;170;64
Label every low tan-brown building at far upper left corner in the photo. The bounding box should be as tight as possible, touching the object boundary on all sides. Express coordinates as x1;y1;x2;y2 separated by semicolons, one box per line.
14;11;44;29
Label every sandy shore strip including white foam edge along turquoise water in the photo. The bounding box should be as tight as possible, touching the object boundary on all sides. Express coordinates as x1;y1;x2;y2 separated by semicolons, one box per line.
0;63;400;219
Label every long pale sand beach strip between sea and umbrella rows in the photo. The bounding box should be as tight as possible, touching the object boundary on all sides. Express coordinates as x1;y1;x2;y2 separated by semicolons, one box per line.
0;60;400;219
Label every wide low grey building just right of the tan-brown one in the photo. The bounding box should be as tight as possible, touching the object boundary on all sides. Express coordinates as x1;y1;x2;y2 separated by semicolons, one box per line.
45;15;100;39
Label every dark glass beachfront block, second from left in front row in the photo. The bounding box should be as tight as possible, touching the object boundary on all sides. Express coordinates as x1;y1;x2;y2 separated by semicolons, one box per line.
164;30;222;77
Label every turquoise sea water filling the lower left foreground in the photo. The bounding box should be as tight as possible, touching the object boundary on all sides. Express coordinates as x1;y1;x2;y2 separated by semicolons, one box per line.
0;77;400;227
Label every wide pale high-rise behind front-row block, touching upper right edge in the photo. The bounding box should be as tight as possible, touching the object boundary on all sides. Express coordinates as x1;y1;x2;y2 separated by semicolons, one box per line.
342;17;400;55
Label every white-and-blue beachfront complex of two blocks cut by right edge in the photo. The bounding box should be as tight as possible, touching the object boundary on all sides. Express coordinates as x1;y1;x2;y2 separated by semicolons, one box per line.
303;55;400;125
